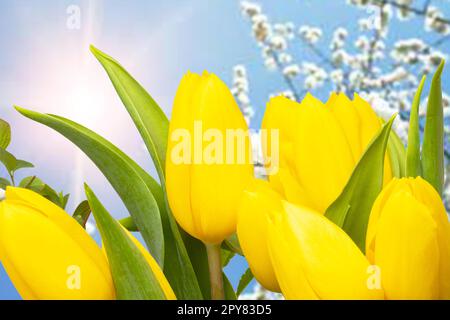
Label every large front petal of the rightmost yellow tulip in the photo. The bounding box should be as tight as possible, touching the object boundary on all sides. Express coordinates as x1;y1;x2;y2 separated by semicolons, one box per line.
374;191;439;299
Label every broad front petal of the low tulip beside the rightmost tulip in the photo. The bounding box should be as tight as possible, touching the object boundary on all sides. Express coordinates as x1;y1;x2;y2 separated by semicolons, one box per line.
267;202;383;299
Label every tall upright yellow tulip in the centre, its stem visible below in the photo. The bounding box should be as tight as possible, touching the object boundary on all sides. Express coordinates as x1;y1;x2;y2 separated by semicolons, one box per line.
166;72;253;244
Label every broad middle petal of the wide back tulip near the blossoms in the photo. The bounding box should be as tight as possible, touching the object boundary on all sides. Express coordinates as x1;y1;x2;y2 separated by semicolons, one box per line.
294;97;354;213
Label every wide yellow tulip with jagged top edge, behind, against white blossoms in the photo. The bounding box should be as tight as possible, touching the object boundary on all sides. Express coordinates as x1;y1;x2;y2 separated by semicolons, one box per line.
262;93;392;213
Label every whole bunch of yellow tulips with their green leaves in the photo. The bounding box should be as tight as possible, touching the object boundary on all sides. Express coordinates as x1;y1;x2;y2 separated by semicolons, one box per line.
0;47;450;299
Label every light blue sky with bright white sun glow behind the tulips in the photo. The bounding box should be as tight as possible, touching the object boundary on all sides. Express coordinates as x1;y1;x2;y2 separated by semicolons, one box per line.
0;0;448;299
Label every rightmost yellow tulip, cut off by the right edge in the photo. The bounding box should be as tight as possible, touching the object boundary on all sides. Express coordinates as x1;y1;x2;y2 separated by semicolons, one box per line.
366;177;450;299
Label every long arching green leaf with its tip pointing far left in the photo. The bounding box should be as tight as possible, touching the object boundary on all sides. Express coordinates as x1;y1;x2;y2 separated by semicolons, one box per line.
16;107;164;265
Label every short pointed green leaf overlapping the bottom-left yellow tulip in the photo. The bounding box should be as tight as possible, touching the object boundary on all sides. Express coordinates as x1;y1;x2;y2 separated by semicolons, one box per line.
85;185;165;300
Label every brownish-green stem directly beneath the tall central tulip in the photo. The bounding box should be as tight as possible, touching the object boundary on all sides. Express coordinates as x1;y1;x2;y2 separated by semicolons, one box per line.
205;244;225;300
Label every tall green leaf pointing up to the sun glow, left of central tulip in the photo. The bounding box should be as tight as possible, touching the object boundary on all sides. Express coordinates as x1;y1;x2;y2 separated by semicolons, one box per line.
91;46;169;184
